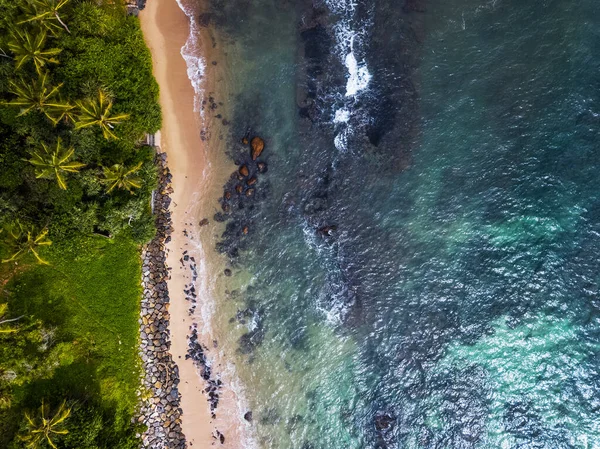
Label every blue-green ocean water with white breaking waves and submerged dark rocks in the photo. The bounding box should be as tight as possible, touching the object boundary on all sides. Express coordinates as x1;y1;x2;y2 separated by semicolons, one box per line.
183;0;600;449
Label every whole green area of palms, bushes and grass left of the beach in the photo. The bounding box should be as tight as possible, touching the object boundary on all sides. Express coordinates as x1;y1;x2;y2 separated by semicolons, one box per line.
0;0;160;449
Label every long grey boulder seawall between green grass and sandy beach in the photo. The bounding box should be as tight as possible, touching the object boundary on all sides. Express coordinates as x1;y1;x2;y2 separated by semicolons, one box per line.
138;153;186;449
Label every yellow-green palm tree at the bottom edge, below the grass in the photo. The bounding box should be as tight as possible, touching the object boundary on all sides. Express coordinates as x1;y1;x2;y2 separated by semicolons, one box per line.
21;400;71;449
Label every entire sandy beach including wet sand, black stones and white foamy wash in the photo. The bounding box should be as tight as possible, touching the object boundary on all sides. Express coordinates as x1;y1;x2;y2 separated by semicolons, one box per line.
139;0;251;449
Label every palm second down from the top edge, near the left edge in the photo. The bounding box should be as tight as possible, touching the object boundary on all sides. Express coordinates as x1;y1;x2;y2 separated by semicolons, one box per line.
8;29;62;76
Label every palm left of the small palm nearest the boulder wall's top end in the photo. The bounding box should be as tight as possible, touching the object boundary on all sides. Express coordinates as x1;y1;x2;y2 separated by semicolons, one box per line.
29;138;85;190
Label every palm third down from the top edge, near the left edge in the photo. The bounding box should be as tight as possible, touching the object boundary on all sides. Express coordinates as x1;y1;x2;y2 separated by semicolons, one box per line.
8;72;73;125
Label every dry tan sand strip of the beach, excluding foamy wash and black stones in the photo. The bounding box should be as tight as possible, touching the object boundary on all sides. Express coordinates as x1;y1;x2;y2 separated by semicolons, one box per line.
139;0;213;448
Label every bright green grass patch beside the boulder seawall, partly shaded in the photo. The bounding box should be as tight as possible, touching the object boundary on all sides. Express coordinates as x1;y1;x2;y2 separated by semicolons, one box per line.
0;237;141;447
